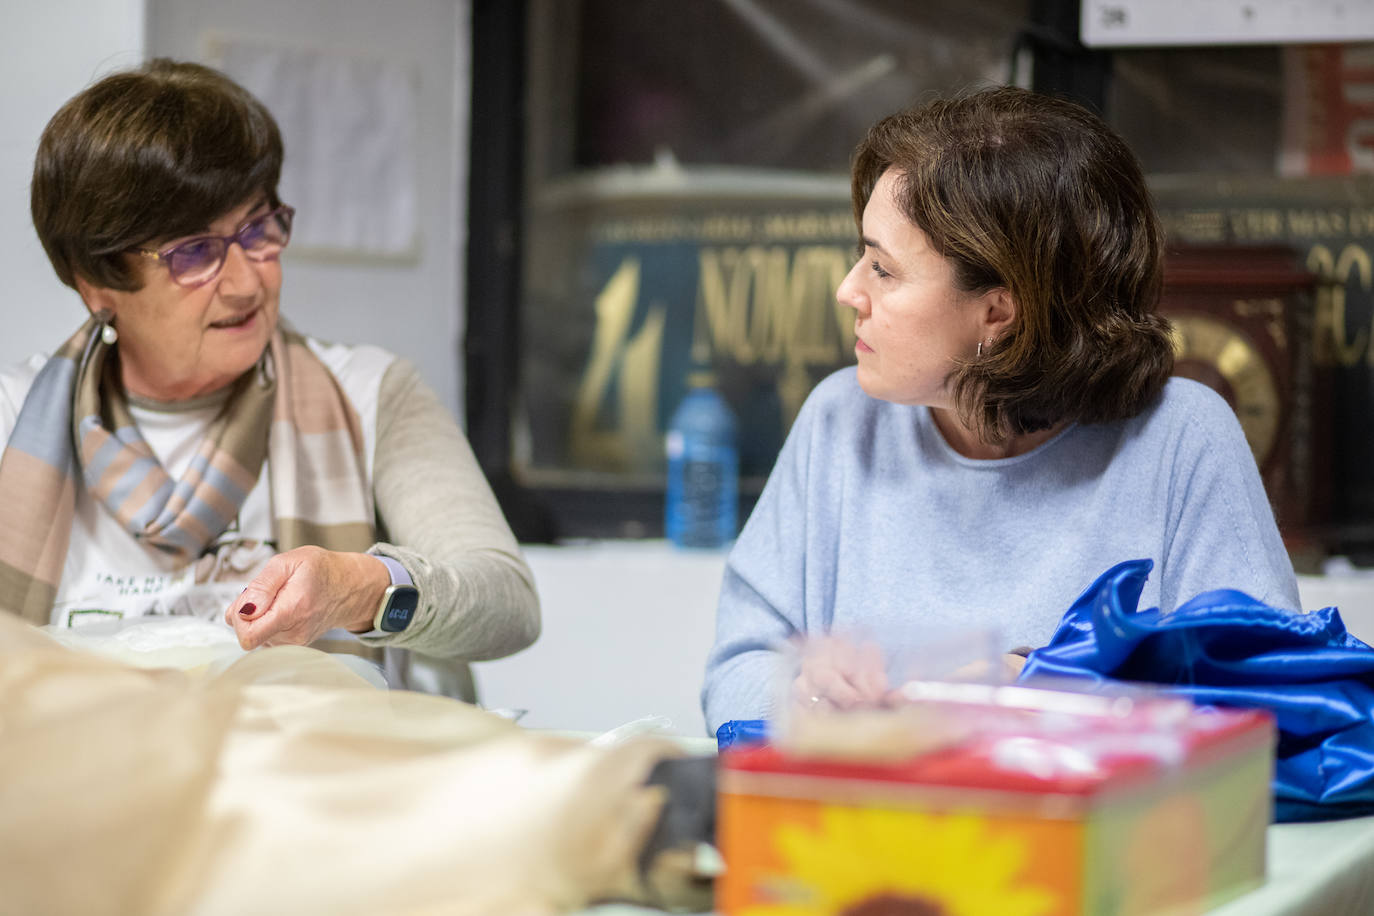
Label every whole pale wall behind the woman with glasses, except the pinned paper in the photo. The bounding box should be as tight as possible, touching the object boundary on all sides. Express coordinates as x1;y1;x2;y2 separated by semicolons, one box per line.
0;0;470;413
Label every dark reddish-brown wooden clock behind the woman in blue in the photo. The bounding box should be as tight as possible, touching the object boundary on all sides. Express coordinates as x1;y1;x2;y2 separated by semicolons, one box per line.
1160;246;1330;566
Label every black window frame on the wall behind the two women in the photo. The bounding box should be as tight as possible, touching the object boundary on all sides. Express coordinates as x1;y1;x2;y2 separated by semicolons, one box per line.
463;0;1110;542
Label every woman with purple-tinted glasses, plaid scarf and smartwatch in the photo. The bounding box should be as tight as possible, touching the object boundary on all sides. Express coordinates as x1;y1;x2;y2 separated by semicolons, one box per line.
0;60;539;692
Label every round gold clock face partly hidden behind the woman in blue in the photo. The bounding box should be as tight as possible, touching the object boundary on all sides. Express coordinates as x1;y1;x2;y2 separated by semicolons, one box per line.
1169;313;1282;468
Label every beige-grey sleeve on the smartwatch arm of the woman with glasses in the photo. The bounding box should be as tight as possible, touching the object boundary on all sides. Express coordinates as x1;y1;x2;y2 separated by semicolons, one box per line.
360;360;540;661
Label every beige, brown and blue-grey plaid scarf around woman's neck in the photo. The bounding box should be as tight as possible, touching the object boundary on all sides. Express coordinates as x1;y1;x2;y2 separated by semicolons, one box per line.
0;317;375;625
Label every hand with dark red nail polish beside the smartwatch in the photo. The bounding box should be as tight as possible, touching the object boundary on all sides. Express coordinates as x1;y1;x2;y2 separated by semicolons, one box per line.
224;547;392;648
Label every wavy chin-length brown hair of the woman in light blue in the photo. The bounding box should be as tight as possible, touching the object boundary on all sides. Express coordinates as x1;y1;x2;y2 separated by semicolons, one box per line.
852;87;1173;442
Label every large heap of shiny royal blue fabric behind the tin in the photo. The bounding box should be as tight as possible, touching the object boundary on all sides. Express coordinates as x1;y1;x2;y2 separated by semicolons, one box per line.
1021;560;1374;821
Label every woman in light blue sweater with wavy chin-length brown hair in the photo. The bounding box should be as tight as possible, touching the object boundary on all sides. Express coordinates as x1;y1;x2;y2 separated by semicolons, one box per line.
702;88;1298;729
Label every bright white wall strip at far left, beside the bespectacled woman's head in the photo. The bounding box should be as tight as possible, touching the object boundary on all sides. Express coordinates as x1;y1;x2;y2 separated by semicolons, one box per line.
0;0;144;367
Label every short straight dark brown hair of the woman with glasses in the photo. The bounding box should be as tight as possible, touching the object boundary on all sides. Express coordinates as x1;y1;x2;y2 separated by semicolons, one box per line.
29;58;282;290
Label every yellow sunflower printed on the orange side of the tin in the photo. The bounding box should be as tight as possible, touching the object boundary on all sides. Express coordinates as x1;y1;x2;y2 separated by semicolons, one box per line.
742;806;1058;916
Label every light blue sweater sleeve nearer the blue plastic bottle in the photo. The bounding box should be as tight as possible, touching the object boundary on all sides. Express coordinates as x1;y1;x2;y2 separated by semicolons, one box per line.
701;396;816;735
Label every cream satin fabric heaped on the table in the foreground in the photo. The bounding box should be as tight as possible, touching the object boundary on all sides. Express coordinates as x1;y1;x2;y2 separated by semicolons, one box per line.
0;614;687;916
